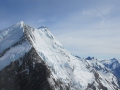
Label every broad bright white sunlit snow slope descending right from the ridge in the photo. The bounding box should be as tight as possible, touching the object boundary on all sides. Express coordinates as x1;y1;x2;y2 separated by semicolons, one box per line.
25;23;94;90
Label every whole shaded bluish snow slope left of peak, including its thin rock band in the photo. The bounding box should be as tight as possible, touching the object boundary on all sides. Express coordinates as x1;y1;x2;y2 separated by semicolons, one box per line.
0;22;31;70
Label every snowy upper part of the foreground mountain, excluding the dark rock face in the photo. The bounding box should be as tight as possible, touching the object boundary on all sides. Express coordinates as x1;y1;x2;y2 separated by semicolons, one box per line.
0;21;119;90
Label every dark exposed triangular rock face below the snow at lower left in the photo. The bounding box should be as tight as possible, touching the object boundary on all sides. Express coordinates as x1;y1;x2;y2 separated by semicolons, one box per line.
0;48;51;90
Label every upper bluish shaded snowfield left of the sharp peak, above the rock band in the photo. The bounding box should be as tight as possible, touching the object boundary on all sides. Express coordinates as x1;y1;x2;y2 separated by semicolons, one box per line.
0;22;23;53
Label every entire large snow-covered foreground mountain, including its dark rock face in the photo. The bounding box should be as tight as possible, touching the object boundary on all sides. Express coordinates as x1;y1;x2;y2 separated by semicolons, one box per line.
0;22;119;90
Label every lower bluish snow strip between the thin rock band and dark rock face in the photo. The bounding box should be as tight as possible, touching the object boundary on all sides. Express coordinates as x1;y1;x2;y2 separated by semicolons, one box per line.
0;42;31;70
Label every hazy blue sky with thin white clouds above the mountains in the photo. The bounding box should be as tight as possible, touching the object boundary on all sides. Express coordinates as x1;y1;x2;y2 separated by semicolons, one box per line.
0;0;120;59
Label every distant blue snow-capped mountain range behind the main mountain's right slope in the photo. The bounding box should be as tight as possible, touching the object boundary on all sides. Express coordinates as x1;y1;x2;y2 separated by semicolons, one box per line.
86;56;120;86
